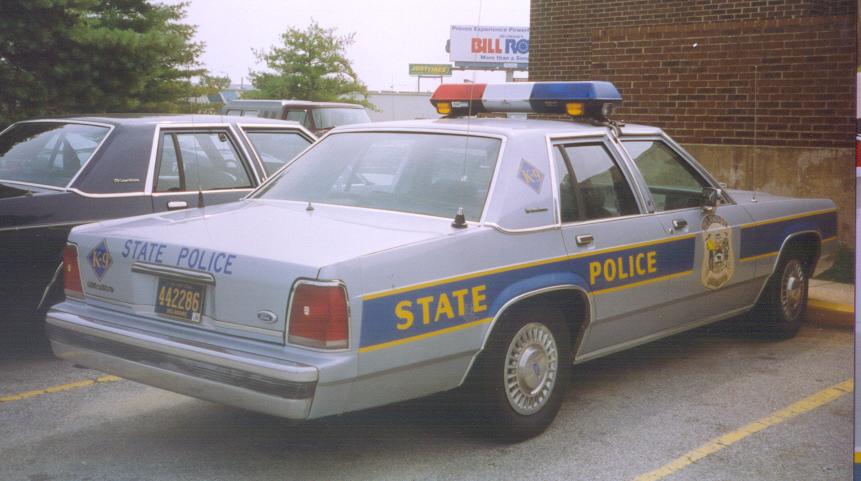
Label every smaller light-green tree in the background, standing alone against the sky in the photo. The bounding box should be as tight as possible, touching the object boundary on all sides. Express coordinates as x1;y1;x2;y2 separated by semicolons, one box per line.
245;20;373;108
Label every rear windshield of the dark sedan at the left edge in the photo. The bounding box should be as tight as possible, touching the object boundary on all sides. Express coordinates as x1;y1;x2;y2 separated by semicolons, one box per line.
0;122;110;187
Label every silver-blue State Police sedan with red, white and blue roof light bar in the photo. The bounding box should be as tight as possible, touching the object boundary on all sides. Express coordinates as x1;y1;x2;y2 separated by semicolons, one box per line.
47;82;837;440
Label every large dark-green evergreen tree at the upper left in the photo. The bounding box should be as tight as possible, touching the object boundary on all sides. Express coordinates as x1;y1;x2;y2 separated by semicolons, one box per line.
0;0;205;124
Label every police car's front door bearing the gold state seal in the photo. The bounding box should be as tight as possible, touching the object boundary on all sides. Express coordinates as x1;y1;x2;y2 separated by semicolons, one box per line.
622;137;759;326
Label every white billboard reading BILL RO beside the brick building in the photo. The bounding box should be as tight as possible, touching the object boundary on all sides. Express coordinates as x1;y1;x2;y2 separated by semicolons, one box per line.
449;25;529;68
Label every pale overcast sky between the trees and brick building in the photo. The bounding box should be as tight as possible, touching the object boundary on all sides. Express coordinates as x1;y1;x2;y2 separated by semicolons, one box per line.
162;0;529;90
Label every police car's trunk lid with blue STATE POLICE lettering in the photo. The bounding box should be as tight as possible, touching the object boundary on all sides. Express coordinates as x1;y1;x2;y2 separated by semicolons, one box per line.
70;201;451;342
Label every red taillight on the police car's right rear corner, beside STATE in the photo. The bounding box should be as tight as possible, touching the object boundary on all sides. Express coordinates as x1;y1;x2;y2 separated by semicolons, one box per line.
287;282;349;349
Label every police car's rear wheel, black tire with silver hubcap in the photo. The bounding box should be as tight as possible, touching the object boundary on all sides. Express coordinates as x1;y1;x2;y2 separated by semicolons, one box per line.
472;309;572;442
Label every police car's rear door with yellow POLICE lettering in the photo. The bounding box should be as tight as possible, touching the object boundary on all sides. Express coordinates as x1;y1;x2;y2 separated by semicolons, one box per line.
553;138;679;358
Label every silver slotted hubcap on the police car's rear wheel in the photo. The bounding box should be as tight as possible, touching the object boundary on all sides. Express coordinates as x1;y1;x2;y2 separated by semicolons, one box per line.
505;322;559;415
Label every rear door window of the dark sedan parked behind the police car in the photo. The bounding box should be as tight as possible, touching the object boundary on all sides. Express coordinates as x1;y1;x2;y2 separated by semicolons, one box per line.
156;131;252;192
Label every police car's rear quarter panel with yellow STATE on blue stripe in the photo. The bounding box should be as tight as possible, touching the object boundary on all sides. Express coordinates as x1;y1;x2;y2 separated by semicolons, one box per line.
332;226;585;410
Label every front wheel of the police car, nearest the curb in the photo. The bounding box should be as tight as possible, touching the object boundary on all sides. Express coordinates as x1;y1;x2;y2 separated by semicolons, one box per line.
751;251;810;339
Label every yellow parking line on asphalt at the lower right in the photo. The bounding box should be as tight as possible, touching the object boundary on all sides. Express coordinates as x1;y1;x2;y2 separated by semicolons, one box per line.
632;379;853;481
